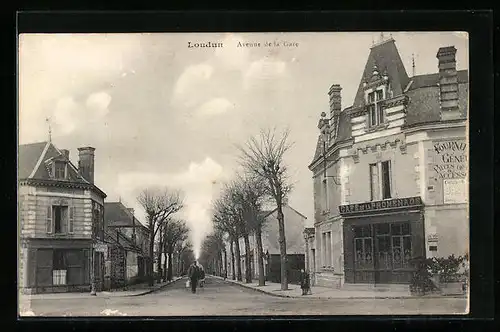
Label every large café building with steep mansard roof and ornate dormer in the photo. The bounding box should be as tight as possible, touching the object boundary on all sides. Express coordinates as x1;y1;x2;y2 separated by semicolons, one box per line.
306;38;469;287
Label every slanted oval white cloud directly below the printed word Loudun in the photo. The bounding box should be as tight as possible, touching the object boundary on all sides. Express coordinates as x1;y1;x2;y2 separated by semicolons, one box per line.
172;63;214;106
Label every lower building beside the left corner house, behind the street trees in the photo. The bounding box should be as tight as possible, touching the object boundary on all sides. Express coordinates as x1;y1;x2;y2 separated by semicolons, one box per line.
104;202;149;288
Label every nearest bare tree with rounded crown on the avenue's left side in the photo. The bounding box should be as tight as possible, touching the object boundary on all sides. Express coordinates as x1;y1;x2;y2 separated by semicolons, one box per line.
137;188;183;286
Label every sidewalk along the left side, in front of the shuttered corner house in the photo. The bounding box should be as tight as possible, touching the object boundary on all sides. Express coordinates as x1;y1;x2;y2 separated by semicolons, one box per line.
20;277;182;301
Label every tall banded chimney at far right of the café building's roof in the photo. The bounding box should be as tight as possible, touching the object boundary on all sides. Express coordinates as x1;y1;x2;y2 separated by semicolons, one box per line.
436;46;460;120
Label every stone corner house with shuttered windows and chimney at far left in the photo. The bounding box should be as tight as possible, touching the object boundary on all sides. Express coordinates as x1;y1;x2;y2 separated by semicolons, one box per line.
18;142;106;293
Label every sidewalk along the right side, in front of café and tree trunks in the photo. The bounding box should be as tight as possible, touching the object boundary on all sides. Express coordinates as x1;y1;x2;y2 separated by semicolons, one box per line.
211;276;465;299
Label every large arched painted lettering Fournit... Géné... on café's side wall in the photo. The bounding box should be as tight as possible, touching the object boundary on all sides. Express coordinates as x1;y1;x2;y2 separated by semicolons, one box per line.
433;140;468;179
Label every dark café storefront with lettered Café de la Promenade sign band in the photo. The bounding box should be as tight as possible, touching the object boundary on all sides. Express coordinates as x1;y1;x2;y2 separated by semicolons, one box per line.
339;197;425;284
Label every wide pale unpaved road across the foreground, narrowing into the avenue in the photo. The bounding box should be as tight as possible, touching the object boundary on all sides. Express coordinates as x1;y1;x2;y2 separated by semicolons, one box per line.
25;278;467;316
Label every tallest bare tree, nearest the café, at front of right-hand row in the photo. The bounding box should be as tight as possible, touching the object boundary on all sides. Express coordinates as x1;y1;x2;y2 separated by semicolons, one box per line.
238;129;292;290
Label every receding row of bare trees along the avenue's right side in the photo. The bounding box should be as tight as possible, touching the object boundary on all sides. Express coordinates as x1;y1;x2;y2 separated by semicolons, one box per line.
202;129;292;290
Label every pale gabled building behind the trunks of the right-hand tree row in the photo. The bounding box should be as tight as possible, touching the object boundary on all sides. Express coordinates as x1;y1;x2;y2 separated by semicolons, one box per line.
226;205;307;282
